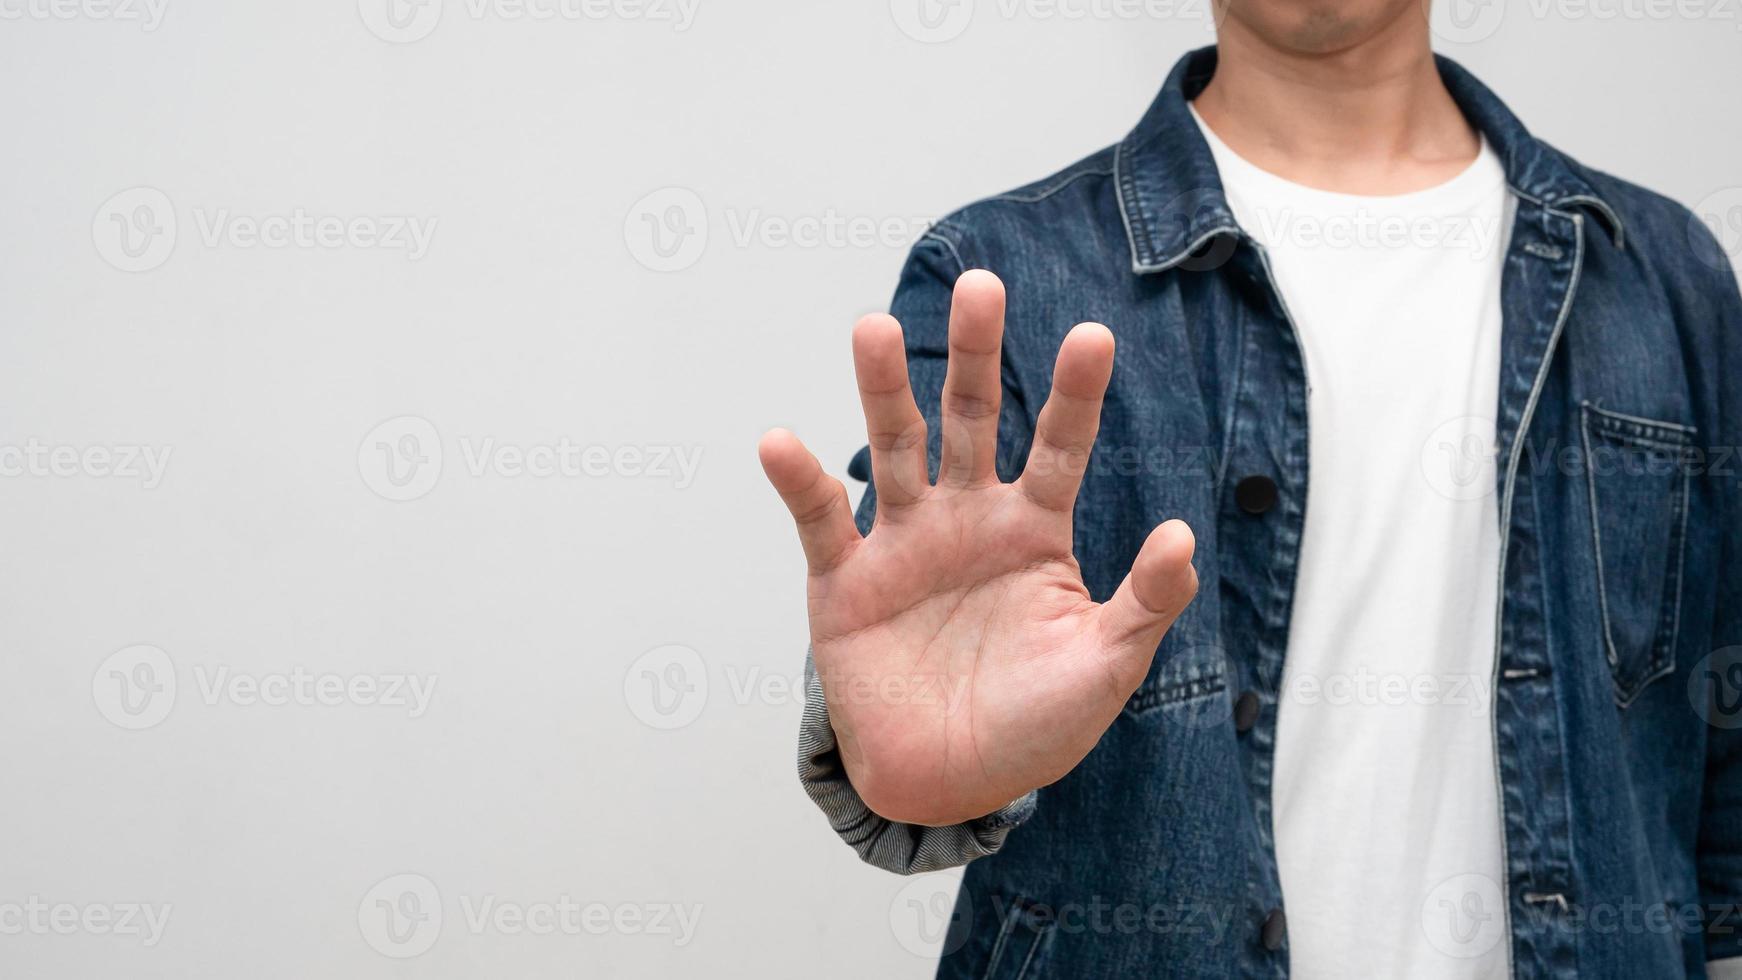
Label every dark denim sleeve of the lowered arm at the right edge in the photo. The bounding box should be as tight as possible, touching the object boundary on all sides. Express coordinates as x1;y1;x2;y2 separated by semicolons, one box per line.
1695;224;1742;980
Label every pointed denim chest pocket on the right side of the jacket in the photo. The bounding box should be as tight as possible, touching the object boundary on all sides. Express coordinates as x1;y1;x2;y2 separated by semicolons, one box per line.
1582;402;1693;707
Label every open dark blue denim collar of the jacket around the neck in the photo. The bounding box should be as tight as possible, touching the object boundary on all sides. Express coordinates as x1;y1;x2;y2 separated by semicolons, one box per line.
1113;47;1622;273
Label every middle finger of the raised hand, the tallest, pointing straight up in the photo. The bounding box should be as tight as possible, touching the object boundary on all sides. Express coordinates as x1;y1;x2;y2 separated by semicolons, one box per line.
937;270;1003;484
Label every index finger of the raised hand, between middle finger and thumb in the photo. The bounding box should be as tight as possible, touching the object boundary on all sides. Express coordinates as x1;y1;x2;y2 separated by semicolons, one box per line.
1017;324;1113;512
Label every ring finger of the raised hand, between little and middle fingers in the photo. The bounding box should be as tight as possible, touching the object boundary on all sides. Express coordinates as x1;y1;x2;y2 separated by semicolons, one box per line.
854;315;932;512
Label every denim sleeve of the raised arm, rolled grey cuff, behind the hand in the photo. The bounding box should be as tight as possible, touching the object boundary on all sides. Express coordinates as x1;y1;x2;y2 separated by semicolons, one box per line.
798;223;1036;874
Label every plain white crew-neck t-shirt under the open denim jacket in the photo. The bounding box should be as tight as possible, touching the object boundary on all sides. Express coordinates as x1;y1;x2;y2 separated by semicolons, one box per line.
1198;103;1516;980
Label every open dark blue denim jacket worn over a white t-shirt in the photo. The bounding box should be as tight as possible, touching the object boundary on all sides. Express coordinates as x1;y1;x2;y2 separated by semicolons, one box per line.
800;49;1742;980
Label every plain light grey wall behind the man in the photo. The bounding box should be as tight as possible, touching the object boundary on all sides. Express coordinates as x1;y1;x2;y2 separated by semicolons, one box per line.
0;0;1742;978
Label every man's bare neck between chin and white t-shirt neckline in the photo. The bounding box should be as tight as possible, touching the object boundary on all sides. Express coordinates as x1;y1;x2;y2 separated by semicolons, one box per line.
1193;10;1481;195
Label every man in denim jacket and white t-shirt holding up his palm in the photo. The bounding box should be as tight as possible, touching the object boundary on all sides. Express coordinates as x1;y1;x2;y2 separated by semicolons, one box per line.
760;0;1742;980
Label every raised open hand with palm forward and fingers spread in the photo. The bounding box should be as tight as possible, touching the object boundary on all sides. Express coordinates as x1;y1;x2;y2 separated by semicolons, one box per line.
760;272;1197;825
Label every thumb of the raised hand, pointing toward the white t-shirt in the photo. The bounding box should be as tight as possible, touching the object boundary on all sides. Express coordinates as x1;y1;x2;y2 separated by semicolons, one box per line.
1097;520;1197;670
